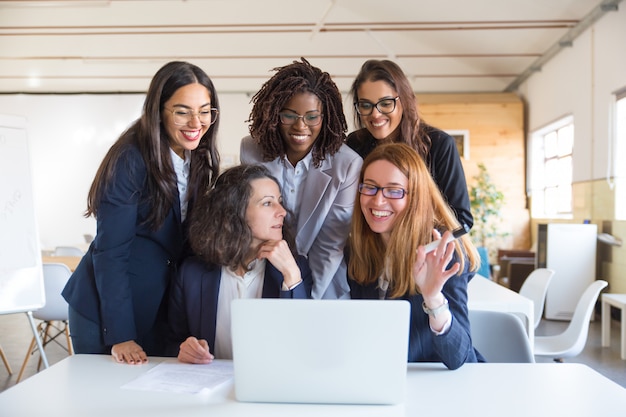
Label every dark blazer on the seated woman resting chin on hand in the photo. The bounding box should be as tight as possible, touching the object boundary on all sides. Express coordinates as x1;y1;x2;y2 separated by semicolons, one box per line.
167;255;313;356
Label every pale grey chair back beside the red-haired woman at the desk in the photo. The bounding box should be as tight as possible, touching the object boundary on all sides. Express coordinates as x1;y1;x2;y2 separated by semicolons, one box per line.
469;310;535;363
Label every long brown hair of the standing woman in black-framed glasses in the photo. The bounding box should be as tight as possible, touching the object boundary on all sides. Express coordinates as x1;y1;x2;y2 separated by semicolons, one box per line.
350;59;431;161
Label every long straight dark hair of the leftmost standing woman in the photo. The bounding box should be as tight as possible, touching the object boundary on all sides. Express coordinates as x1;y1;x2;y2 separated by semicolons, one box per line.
85;61;220;230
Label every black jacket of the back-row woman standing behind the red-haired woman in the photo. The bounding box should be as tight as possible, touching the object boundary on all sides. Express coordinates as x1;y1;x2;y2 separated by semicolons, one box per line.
346;126;474;228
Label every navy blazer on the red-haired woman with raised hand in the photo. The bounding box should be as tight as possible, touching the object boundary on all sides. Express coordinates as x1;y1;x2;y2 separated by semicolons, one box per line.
348;249;485;369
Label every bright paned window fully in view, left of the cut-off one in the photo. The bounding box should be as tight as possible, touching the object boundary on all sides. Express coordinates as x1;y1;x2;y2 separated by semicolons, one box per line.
530;116;574;218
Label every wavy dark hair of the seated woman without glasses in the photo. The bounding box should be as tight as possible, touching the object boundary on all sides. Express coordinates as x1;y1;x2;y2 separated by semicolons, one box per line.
189;164;295;269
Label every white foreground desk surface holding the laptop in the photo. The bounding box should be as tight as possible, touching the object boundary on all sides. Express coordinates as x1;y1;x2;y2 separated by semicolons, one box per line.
0;355;626;417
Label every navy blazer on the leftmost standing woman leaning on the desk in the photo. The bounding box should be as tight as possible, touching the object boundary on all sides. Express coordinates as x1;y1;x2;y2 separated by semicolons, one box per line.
62;145;185;355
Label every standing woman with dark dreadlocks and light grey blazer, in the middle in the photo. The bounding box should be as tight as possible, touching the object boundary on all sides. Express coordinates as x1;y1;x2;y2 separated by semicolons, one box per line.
240;58;362;298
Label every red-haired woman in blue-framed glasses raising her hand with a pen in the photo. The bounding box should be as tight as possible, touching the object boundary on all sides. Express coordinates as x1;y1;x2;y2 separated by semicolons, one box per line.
347;143;483;369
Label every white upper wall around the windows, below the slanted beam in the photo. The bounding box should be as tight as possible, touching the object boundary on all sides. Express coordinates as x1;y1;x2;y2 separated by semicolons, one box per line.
520;5;626;182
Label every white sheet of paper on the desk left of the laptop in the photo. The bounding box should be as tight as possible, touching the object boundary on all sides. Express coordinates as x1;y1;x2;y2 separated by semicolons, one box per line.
122;360;233;394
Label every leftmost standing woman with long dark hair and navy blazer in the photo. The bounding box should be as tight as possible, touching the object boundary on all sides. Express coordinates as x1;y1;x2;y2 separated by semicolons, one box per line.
63;62;219;364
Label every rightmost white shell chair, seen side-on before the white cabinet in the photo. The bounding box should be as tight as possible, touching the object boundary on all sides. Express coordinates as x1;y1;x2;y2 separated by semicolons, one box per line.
535;280;608;362
